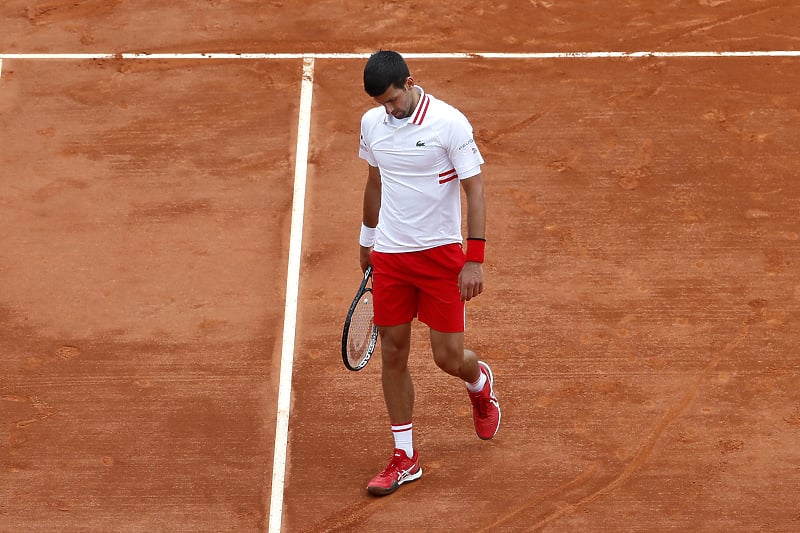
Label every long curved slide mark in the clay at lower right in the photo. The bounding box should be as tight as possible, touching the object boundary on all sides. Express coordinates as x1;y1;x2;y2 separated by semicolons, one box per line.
530;324;750;531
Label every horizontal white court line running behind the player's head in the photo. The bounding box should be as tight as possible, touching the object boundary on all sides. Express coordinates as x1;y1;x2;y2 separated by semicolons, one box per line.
0;50;800;60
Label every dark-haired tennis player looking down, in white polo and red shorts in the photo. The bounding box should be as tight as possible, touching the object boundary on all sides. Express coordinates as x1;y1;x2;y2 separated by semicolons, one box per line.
359;50;500;495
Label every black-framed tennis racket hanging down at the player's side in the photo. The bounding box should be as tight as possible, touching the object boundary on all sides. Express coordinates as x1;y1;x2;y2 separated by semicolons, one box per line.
342;265;378;372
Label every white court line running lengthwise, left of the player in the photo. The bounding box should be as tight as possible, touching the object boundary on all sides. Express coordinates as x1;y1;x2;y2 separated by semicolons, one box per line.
269;56;314;533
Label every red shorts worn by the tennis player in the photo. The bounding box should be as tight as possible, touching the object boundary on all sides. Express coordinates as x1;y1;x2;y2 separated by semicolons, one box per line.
371;243;466;333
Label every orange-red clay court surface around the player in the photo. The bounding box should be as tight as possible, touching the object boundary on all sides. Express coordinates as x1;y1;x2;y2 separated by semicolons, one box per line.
0;0;800;532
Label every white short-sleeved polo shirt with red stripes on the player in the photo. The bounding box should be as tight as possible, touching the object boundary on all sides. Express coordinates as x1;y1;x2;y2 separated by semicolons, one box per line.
358;85;483;253
